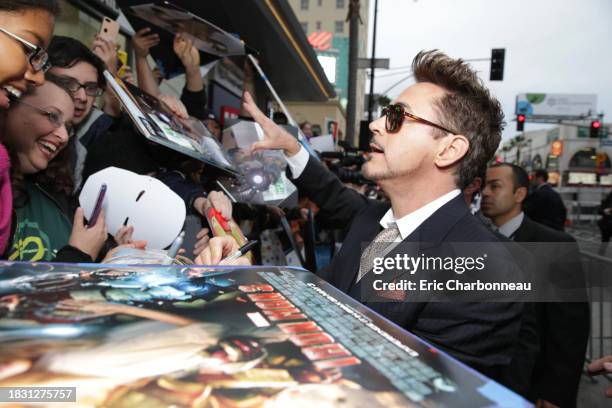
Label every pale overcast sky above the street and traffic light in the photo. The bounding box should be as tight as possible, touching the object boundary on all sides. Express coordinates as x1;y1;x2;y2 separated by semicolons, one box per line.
366;0;612;139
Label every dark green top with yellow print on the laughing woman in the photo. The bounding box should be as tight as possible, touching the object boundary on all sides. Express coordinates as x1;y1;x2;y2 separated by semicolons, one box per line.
9;182;72;262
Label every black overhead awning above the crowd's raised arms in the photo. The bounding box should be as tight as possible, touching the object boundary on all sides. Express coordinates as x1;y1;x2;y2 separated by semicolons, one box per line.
117;0;335;102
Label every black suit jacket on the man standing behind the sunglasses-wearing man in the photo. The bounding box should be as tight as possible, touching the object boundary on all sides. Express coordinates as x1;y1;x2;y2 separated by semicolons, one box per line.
514;216;590;407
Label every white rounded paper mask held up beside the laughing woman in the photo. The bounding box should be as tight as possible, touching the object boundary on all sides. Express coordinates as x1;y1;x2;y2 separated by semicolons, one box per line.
79;167;186;249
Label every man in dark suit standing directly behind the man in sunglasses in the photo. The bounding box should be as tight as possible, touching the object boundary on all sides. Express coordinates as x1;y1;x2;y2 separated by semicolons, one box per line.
481;163;590;407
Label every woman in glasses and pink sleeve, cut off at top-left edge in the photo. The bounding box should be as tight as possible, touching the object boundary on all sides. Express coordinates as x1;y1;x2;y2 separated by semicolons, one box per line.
0;0;59;253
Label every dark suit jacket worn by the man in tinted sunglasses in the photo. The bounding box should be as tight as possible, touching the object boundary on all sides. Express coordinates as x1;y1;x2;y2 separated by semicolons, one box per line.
295;158;523;378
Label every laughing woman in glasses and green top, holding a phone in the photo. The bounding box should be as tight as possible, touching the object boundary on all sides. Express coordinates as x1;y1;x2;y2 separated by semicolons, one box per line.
0;81;107;262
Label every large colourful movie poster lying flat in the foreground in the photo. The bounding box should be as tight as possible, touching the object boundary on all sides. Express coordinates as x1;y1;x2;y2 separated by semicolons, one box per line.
0;263;529;408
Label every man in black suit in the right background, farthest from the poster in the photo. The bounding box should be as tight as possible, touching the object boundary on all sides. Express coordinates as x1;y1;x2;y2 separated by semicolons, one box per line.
523;169;567;231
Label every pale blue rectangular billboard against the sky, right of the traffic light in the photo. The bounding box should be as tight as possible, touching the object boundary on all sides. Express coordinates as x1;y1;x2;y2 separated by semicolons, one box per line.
516;93;597;119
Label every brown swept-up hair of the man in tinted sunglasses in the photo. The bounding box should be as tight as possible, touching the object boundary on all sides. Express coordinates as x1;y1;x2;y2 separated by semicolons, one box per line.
412;50;505;188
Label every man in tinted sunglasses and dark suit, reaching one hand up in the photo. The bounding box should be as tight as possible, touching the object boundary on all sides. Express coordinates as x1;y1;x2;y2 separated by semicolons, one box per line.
205;51;523;377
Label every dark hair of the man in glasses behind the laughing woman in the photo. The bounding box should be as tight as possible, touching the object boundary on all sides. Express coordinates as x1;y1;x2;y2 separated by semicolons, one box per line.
47;35;106;89
